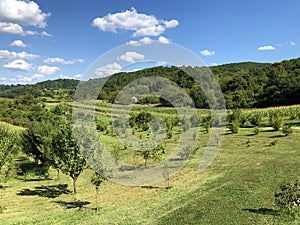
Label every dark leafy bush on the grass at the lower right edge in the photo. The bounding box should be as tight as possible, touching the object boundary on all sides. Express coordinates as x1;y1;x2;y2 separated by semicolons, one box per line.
274;181;300;213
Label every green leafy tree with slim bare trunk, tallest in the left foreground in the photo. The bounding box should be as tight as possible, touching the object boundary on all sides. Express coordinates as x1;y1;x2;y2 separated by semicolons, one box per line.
52;121;86;193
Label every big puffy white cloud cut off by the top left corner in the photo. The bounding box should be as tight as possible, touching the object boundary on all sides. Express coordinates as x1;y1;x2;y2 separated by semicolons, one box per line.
0;0;50;28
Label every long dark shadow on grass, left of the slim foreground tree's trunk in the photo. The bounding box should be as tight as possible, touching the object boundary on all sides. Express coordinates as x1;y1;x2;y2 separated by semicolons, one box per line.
18;184;71;198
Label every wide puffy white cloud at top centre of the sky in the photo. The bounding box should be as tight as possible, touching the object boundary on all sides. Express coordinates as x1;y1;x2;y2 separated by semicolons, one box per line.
92;8;179;37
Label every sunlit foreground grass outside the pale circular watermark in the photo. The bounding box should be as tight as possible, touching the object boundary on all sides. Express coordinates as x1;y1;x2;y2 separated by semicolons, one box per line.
0;113;300;225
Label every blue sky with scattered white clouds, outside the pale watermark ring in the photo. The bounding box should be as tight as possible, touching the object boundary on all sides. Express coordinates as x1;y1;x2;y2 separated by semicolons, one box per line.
0;0;300;84
